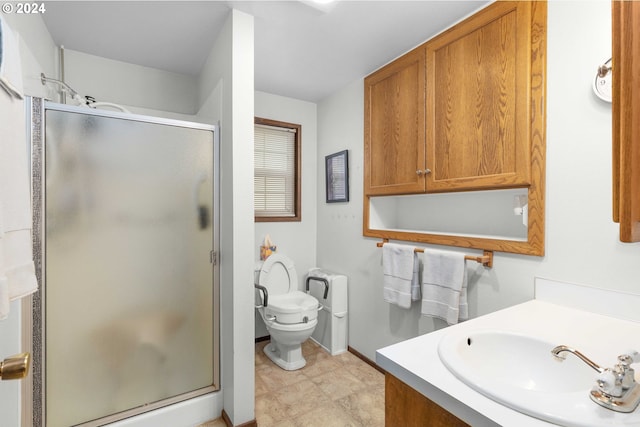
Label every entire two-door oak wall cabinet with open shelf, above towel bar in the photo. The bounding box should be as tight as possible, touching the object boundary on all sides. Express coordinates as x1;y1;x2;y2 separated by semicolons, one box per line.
363;1;547;255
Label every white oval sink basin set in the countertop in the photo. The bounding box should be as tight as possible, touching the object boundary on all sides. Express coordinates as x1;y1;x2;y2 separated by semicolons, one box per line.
438;330;640;427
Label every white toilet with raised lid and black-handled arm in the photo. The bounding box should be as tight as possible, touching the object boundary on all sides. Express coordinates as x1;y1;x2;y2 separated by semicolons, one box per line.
255;253;322;371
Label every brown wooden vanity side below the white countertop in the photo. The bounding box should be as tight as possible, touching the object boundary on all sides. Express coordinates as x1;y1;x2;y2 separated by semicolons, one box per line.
384;373;470;427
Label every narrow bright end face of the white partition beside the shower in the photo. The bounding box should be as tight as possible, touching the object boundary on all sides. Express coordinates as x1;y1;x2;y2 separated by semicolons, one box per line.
226;10;255;425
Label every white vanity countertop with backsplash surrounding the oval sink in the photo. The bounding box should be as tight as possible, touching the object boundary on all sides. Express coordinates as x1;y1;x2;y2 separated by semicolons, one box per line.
376;279;640;427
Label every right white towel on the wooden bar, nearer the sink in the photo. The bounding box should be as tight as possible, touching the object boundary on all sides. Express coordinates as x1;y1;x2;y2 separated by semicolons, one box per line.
421;249;469;325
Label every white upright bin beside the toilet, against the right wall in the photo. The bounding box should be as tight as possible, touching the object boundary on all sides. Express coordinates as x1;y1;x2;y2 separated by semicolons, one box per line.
304;268;349;355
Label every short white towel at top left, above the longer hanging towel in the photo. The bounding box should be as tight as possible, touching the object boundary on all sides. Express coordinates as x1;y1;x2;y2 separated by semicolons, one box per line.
0;15;23;99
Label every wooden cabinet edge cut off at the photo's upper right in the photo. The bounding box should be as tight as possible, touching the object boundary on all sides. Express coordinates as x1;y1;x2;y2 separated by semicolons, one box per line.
611;0;640;243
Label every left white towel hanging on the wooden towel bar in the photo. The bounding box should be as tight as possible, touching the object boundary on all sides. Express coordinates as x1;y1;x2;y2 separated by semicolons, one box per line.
382;243;420;308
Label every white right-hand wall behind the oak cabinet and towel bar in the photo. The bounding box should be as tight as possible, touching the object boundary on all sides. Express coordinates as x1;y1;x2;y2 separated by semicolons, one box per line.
317;0;640;359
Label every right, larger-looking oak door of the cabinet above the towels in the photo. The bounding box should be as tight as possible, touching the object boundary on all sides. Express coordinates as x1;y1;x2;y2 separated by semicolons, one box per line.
426;1;532;191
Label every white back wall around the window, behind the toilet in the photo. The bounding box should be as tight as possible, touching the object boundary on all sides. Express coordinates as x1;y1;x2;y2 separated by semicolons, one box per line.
252;92;324;337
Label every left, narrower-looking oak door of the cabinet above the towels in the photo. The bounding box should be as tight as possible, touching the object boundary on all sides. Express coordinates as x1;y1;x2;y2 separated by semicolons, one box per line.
364;48;425;195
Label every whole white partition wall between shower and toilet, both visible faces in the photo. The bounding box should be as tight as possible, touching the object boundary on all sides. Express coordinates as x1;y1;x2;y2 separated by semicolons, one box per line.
198;10;254;425
